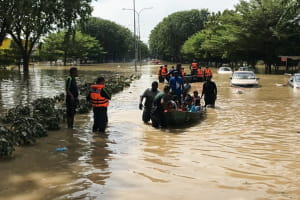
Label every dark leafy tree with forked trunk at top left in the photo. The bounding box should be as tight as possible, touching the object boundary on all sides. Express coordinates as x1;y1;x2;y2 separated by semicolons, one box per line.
8;0;92;72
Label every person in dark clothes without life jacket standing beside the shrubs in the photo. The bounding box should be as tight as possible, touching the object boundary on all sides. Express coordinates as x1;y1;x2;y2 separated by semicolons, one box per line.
66;67;78;128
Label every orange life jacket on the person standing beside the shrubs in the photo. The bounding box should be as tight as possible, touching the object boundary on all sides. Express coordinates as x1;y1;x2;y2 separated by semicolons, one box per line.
90;85;109;107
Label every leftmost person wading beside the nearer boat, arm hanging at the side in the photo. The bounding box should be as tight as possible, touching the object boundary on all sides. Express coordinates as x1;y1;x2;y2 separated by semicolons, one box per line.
139;81;159;123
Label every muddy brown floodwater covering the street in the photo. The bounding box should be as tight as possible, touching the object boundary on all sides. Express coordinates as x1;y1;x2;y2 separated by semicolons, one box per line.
0;66;300;200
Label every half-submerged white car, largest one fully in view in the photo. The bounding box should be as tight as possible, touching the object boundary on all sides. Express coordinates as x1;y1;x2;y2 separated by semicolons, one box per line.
230;71;259;87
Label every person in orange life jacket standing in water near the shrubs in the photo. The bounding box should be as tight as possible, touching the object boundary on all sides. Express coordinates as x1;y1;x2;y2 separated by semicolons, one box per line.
89;77;111;132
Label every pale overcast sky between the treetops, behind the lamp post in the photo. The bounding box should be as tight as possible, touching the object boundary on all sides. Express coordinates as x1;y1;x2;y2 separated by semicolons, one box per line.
92;0;239;42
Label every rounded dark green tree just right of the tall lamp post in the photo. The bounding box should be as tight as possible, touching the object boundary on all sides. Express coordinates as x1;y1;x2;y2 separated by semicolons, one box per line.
149;9;209;61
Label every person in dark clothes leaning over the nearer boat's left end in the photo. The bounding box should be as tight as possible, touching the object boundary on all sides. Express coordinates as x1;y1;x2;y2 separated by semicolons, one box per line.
151;85;170;128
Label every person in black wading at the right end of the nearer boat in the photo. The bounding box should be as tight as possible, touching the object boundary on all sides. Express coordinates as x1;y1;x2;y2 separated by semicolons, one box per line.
200;76;218;108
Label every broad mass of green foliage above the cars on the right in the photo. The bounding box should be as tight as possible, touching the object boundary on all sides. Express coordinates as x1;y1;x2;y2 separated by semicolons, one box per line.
181;0;300;68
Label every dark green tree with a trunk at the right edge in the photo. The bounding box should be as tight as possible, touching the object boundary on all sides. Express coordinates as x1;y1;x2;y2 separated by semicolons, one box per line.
236;0;300;72
